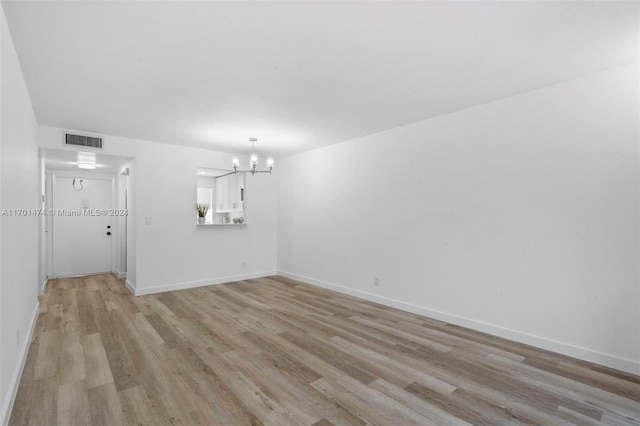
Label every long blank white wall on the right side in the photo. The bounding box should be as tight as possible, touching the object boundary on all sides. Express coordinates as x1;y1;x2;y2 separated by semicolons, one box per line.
278;65;640;374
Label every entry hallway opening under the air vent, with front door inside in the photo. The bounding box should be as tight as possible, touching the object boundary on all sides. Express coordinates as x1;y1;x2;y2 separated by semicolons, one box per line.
38;148;134;294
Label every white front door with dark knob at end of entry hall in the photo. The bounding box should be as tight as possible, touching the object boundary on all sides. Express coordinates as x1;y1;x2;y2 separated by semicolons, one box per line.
52;176;114;277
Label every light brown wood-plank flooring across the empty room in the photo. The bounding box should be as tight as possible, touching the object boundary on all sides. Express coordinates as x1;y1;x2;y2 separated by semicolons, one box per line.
10;275;640;426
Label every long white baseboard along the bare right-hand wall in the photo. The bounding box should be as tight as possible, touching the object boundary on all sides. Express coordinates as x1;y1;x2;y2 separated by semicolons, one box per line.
278;271;640;375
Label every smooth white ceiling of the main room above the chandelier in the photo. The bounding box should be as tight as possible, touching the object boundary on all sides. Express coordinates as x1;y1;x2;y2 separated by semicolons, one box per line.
2;1;639;157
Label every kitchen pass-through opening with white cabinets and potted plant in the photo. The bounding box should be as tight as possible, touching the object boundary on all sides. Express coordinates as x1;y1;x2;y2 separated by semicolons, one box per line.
196;167;246;225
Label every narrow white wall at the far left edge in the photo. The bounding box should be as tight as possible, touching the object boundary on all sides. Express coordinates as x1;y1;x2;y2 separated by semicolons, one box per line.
0;8;39;424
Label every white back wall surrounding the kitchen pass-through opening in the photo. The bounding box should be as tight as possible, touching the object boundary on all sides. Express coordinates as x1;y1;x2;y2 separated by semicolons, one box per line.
38;127;277;294
